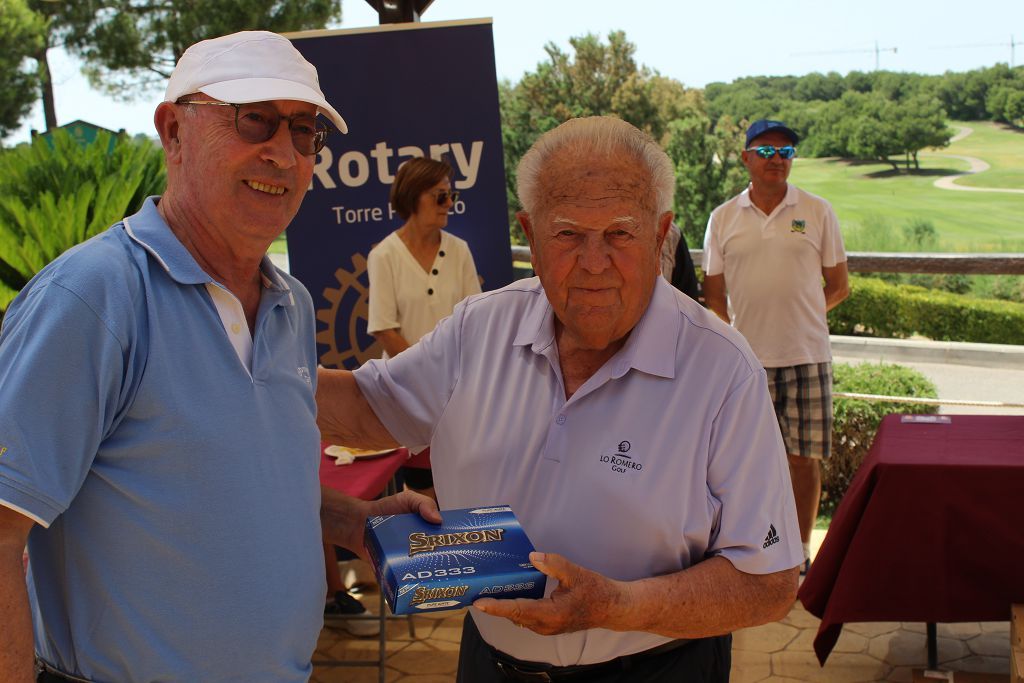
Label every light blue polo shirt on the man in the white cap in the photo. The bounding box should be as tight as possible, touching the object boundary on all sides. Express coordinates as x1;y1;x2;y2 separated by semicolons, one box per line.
0;199;326;683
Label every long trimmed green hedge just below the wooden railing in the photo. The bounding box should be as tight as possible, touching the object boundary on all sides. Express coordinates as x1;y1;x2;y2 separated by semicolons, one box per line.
828;276;1024;344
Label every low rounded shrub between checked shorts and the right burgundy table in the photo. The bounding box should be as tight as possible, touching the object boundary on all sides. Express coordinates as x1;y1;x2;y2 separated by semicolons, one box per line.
821;362;938;516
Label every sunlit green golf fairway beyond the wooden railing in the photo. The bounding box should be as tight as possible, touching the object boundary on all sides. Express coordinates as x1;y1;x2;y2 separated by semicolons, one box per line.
790;122;1024;252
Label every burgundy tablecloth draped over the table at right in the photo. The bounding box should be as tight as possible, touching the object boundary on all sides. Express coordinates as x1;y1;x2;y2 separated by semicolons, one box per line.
799;415;1024;665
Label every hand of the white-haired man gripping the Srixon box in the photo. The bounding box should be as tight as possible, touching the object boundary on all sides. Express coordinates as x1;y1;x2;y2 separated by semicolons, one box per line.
473;553;629;636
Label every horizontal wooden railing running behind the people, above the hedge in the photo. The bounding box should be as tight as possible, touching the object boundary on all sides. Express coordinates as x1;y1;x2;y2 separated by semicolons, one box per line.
512;246;1024;275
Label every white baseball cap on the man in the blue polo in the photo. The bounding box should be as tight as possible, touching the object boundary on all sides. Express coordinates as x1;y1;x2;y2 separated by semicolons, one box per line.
164;31;348;133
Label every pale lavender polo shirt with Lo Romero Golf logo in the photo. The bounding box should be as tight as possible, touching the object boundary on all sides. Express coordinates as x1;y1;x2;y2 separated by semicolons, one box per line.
355;278;803;666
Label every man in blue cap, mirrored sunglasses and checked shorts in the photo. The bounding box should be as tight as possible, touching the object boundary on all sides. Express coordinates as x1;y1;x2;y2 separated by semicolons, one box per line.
702;119;850;572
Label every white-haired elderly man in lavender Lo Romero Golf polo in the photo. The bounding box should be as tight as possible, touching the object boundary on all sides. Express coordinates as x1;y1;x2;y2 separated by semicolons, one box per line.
316;117;801;683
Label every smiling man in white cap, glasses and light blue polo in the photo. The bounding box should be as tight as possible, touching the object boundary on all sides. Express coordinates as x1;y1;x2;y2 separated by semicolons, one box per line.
0;32;439;683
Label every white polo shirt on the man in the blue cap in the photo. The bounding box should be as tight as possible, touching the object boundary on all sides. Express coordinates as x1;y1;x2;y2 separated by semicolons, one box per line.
701;184;846;368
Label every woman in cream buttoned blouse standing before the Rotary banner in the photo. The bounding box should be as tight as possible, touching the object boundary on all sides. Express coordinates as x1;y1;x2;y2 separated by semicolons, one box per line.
367;158;480;496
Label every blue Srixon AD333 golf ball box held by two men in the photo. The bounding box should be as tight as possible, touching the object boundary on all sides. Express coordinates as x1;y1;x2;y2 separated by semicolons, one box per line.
366;505;545;614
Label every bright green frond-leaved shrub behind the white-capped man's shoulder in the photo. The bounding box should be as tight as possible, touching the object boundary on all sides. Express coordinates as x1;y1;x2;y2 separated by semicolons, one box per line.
0;130;166;309
